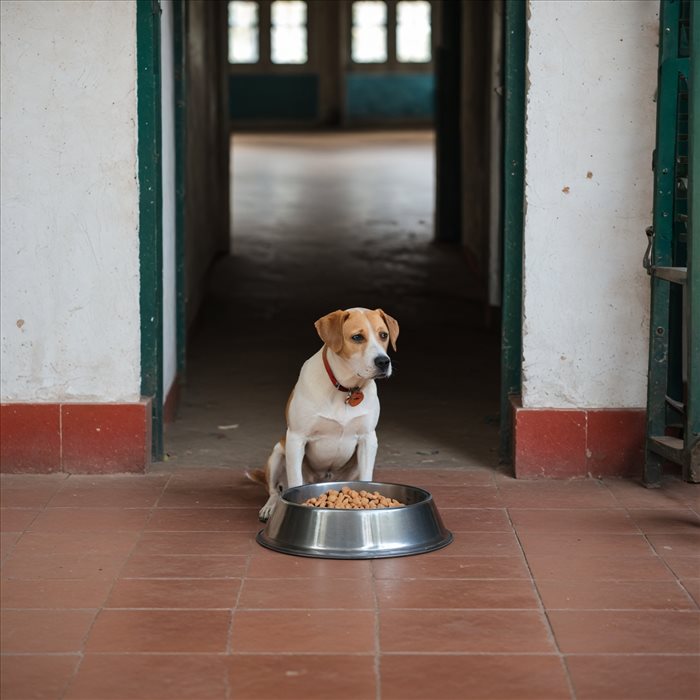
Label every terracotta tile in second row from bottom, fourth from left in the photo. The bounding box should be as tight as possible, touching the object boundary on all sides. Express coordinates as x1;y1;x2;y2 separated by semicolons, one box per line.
379;610;554;654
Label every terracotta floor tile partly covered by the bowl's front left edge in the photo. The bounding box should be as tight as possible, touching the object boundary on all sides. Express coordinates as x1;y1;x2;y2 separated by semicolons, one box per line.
246;545;371;578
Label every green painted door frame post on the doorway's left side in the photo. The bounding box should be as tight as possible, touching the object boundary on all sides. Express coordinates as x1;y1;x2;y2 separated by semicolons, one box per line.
136;0;163;461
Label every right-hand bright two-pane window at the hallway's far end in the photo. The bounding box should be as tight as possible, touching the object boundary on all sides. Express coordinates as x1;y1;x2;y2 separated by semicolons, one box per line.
350;0;432;66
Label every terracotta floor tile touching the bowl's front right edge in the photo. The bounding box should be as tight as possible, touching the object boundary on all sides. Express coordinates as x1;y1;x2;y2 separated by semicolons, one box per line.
372;550;530;580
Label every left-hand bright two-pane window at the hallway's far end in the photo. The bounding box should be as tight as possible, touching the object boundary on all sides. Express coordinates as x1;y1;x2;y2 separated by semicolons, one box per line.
228;0;308;67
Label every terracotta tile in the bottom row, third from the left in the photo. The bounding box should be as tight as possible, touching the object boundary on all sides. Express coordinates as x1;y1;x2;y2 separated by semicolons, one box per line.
228;654;377;700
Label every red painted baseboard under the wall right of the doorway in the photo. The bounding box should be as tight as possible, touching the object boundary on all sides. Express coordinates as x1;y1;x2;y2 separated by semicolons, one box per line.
511;398;646;479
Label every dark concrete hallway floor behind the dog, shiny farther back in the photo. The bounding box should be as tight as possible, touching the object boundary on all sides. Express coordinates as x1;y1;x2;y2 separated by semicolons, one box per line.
161;131;499;478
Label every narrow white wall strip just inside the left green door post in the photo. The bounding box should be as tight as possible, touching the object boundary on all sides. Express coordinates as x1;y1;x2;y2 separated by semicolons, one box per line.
160;0;177;401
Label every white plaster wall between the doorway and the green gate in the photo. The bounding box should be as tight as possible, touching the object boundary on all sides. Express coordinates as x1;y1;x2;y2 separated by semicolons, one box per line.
523;0;658;408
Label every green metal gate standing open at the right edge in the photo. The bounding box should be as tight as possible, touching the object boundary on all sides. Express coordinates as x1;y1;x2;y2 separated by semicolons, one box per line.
644;0;700;487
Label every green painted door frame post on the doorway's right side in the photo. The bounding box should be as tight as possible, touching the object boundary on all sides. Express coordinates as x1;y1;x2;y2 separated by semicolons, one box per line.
500;0;527;462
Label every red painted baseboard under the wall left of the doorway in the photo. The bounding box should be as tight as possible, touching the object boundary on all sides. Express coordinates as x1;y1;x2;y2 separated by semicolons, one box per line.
0;400;151;474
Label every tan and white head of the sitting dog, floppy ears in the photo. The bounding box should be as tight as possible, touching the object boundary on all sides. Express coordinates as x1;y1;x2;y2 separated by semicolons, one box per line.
315;308;399;379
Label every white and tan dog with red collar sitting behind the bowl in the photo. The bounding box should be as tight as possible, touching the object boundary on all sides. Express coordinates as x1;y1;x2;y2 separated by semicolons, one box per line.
248;307;399;522
